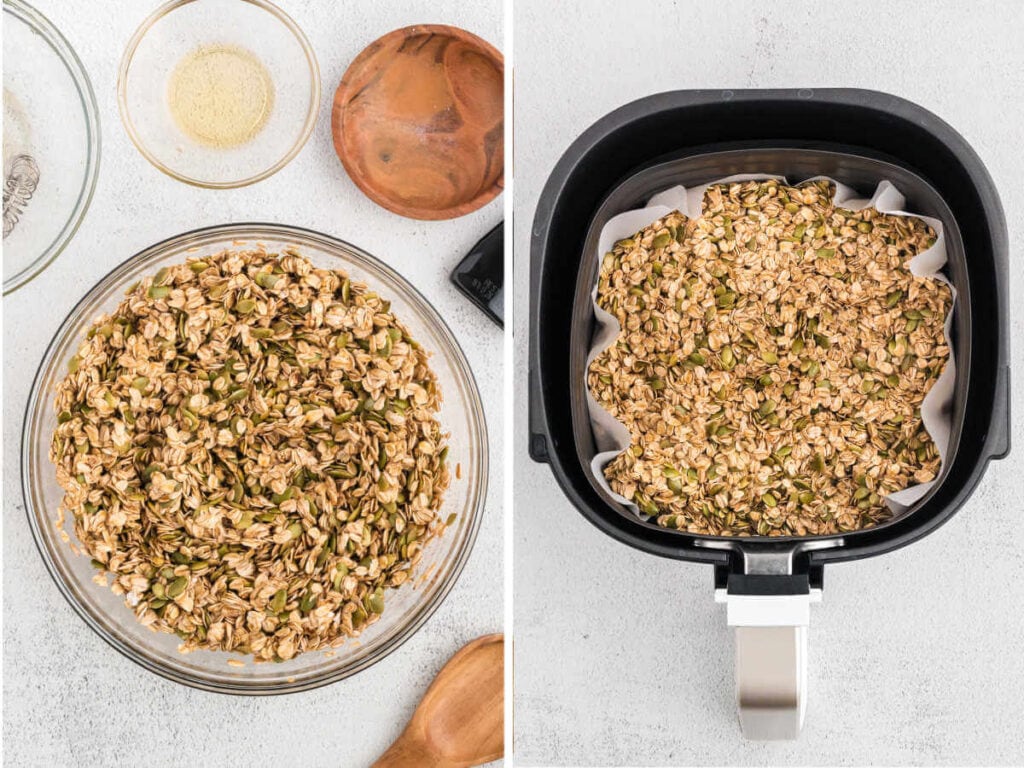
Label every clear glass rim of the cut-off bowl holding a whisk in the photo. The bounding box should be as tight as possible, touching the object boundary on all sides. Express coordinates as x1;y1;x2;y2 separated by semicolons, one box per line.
3;0;101;296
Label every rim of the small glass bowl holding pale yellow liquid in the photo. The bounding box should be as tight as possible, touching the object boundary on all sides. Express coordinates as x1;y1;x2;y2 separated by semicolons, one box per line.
118;0;321;189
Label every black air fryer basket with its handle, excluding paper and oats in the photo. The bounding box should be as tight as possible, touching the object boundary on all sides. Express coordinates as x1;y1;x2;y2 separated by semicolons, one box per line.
529;89;1010;738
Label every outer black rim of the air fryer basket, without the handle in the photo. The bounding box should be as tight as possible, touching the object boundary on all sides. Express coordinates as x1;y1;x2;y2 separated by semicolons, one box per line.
529;89;1010;565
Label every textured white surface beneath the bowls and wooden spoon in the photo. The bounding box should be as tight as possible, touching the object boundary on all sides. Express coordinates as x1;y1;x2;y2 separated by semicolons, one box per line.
3;0;503;768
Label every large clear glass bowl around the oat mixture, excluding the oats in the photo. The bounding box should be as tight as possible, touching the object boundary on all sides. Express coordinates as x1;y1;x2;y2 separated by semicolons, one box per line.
22;224;487;695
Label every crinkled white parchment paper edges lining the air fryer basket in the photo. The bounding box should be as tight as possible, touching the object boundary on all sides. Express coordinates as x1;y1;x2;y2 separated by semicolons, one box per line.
586;174;956;517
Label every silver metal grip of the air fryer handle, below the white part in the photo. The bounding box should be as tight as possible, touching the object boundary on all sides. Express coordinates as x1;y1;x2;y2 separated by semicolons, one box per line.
735;626;807;740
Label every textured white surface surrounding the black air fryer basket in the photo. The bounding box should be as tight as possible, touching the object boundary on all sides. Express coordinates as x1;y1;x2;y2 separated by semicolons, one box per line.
513;0;1024;765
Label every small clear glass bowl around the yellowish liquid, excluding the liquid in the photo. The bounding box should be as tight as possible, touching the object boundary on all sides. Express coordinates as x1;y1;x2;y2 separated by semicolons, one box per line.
118;0;321;189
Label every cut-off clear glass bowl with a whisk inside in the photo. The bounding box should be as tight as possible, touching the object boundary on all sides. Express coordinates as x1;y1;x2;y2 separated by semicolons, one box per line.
3;0;99;294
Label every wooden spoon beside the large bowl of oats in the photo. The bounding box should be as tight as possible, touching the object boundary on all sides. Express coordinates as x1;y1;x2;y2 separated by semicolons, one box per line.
374;635;505;768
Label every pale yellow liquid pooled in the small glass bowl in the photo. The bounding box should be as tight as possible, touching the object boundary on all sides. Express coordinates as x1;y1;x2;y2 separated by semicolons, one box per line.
167;45;273;147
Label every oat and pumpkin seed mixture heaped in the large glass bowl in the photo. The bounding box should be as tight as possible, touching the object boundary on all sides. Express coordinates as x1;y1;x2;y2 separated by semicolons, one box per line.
50;251;452;660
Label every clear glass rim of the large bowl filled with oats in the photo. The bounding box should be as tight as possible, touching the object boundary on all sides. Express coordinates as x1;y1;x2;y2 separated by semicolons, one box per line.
22;222;488;695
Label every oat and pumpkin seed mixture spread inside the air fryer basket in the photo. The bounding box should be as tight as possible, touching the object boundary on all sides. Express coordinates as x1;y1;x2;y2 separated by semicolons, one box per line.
588;181;951;536
